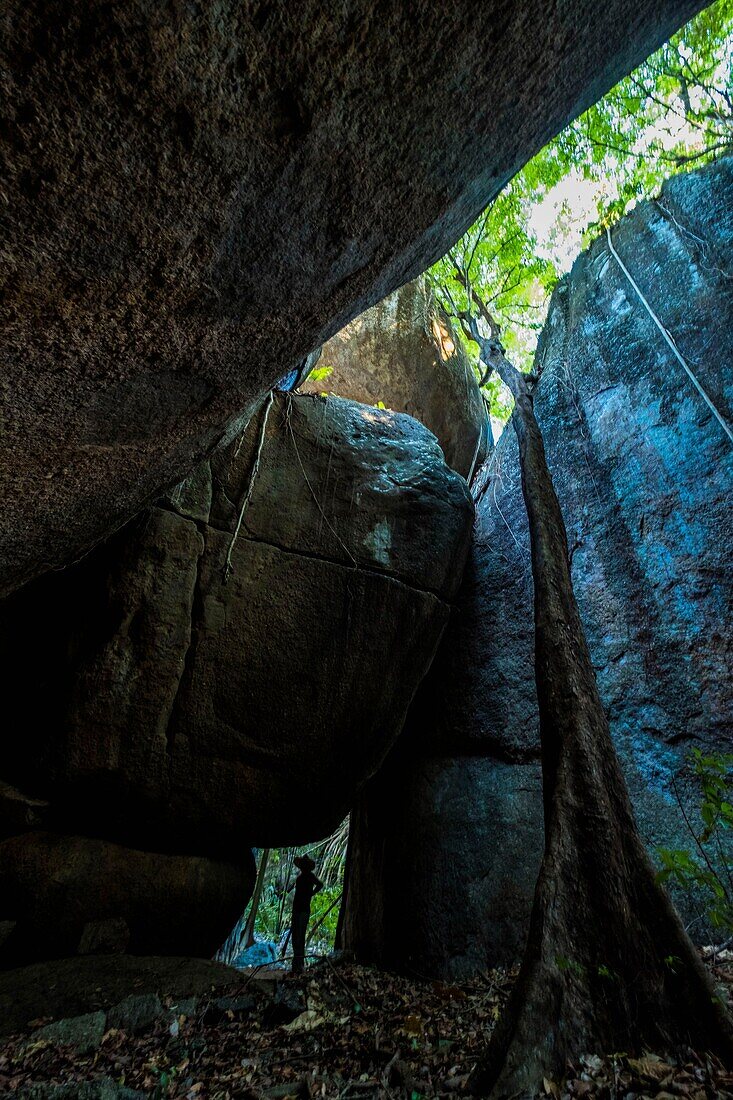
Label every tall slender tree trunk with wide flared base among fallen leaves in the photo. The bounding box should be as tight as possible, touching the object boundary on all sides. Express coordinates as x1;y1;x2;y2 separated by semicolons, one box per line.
470;341;733;1098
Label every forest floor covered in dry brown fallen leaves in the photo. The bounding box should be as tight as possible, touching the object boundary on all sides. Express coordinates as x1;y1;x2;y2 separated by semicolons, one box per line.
0;952;733;1100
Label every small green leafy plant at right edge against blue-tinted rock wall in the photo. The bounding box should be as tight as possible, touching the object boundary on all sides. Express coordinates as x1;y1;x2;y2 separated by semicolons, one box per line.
657;749;733;935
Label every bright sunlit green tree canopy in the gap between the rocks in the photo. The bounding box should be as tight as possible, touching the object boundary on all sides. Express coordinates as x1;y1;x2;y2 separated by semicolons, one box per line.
429;0;733;420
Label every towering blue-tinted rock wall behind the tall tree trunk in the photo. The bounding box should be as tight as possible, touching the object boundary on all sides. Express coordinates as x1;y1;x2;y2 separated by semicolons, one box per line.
344;160;733;977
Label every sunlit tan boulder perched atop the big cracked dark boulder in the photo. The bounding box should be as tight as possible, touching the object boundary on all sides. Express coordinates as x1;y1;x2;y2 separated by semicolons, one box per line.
303;277;493;477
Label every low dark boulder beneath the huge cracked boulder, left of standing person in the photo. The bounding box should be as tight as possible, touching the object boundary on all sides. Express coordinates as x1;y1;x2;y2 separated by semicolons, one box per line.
0;832;254;967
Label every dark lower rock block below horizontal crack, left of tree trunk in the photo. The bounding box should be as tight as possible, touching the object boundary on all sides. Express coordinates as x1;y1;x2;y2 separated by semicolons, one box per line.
341;752;541;979
